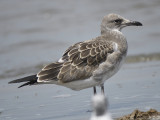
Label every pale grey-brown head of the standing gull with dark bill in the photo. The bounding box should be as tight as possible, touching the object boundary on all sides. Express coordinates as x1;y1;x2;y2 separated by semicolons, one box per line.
101;14;142;33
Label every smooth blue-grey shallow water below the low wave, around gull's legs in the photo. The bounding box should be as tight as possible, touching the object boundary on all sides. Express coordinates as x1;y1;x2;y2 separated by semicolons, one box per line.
0;62;160;120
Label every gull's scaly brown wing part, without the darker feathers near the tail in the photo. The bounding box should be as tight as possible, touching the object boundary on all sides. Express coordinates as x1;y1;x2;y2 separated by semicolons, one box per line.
57;37;114;83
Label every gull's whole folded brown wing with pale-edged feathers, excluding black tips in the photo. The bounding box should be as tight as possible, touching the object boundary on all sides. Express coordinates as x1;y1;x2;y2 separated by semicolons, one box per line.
37;36;114;83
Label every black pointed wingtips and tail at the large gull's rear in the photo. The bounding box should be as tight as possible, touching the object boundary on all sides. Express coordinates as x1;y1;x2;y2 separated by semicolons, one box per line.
9;75;38;88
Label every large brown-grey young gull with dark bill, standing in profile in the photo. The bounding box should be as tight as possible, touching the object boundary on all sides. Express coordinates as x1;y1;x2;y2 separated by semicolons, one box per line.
9;14;142;94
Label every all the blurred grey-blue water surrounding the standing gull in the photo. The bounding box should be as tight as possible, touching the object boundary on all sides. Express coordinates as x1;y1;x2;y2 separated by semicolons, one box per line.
0;0;160;120
